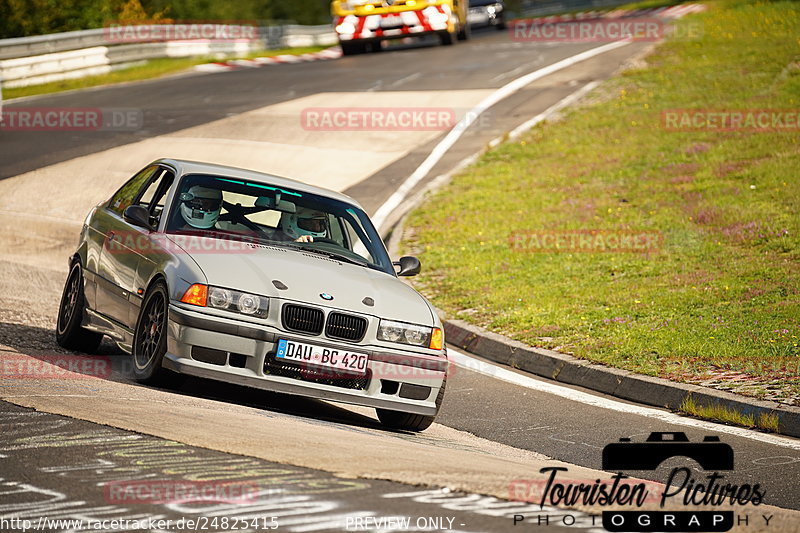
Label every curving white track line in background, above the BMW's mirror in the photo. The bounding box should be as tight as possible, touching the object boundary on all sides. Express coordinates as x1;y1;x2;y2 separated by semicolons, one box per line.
372;40;630;229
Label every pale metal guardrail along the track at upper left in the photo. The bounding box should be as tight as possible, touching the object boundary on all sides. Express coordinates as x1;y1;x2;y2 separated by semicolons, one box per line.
0;24;336;87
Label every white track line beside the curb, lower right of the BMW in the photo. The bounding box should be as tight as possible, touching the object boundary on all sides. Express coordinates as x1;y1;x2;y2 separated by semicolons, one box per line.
447;346;800;451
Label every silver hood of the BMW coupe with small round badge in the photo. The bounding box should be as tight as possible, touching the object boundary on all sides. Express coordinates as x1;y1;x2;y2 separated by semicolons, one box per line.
168;235;434;326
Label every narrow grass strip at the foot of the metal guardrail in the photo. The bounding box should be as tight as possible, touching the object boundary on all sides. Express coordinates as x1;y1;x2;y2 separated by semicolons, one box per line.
3;46;327;100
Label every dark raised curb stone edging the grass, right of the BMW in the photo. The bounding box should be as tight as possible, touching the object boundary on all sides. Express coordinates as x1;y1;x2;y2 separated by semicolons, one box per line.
444;320;800;437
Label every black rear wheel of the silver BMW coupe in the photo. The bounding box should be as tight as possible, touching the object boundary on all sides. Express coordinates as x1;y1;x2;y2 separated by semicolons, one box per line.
56;261;103;354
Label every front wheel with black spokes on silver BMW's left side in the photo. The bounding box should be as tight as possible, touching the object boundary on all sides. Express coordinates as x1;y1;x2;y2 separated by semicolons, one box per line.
131;280;172;384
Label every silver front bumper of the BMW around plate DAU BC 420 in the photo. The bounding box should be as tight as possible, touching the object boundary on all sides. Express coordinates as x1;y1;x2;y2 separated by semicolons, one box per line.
163;305;447;416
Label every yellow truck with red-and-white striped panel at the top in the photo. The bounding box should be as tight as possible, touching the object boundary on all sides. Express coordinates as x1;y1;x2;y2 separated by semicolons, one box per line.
331;0;470;55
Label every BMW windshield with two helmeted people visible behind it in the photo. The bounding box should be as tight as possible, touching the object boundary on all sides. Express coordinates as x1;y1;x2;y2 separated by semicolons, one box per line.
167;174;394;275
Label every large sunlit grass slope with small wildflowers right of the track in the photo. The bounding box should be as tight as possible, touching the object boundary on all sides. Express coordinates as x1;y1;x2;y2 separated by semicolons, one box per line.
402;0;800;400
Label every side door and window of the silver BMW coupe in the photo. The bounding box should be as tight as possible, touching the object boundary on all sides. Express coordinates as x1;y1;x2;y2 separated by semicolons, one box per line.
97;166;174;330
